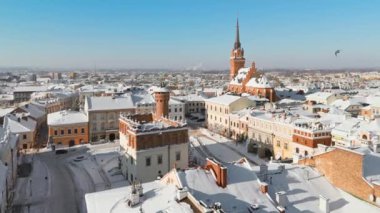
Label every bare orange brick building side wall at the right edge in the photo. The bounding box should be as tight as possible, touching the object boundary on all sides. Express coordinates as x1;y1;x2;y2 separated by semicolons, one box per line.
299;147;380;206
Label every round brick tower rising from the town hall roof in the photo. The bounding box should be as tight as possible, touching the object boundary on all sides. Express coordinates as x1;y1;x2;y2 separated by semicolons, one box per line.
154;85;170;119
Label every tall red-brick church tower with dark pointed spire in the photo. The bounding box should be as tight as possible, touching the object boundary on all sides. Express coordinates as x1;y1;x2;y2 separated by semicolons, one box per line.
230;20;245;80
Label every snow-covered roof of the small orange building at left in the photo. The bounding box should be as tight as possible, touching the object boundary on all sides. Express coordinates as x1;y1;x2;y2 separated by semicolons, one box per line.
47;110;88;126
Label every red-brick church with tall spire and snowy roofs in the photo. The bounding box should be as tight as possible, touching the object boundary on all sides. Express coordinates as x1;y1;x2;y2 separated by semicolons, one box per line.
228;19;277;102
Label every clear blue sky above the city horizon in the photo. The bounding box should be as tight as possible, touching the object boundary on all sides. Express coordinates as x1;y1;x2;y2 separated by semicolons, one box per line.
0;0;380;69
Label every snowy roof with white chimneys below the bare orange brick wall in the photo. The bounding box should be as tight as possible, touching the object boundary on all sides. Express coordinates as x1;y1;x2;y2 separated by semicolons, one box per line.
253;163;380;213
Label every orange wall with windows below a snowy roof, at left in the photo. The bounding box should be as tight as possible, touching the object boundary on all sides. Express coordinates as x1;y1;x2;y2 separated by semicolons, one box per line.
49;123;89;146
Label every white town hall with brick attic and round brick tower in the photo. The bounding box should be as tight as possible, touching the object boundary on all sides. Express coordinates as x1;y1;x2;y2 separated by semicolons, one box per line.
119;88;189;182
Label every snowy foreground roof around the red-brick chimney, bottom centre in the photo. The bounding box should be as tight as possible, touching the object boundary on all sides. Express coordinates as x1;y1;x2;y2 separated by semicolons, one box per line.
178;164;277;212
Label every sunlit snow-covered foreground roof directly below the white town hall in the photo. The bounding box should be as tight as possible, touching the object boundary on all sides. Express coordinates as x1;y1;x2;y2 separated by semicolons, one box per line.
85;181;193;213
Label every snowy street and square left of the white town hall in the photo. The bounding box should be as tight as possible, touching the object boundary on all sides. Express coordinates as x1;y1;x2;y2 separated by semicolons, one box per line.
11;144;127;213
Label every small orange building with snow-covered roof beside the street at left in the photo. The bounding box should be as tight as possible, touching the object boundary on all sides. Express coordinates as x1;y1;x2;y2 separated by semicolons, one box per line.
47;111;89;146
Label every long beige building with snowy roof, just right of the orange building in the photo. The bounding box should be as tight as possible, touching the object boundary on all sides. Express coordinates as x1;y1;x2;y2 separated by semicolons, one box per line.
84;90;155;142
